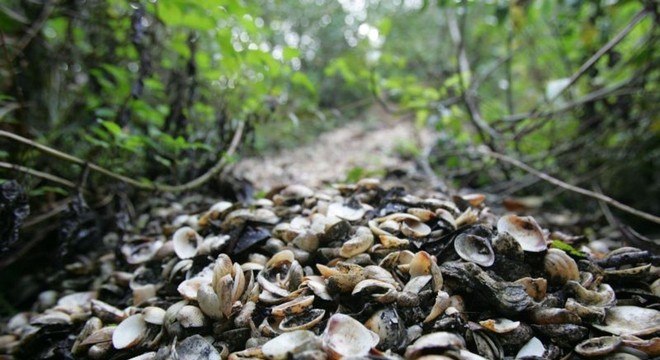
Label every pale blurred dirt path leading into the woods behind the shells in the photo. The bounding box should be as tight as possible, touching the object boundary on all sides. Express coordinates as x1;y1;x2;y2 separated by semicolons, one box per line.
234;108;438;189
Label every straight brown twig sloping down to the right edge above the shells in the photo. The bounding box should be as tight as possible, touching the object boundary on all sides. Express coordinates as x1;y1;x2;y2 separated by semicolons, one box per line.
476;147;660;224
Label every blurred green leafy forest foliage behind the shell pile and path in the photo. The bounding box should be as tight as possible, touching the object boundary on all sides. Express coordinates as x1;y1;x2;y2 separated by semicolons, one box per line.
0;0;660;228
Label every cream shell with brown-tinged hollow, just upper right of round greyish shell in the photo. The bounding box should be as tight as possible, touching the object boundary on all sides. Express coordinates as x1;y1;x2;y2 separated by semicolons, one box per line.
497;215;548;252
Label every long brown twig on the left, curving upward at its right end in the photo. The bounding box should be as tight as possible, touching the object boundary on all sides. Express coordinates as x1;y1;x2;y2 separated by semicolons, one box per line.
0;122;245;192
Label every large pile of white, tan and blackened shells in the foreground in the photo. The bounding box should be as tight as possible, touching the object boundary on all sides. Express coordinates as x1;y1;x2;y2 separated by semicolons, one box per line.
0;179;660;360
